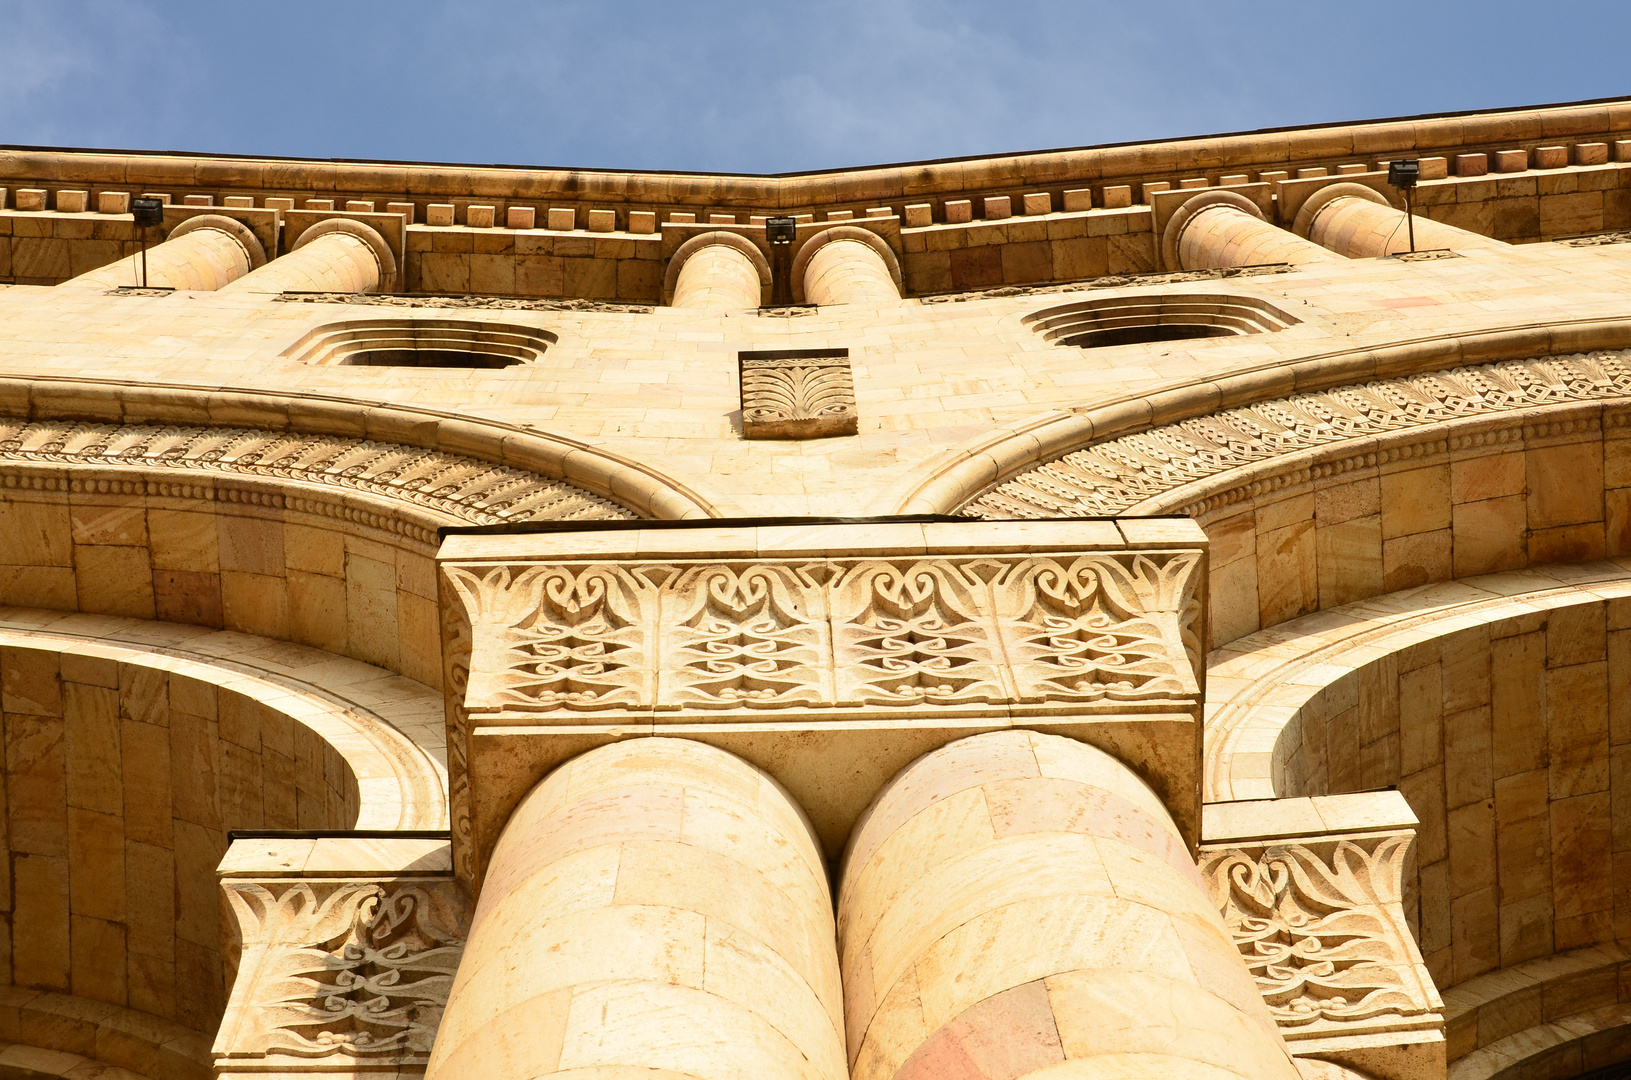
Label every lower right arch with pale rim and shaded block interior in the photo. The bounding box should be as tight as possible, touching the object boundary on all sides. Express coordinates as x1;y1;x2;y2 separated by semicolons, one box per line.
1204;561;1631;1077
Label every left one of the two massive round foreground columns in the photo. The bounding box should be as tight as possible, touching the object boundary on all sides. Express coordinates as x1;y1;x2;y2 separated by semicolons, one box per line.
427;737;846;1080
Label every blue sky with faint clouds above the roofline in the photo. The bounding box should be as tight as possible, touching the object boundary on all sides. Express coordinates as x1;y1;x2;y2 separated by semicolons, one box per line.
0;0;1631;173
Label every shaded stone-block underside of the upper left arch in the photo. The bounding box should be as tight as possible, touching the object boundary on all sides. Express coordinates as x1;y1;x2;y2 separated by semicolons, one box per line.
0;489;442;687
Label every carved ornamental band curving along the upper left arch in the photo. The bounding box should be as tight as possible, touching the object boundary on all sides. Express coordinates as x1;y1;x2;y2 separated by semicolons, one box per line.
0;419;633;524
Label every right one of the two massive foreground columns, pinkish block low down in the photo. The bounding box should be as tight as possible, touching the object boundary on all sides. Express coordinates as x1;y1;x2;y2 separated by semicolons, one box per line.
838;731;1297;1080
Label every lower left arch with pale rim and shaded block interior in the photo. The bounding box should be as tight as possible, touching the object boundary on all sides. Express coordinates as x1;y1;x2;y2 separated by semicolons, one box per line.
0;609;447;1080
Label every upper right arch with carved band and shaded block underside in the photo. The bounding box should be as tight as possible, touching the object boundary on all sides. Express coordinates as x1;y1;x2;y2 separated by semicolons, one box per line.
932;321;1631;646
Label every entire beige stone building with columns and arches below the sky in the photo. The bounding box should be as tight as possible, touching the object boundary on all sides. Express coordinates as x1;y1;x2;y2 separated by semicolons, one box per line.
0;101;1631;1080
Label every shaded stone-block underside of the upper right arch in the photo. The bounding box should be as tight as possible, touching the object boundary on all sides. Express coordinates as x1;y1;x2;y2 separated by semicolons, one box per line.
1199;405;1631;646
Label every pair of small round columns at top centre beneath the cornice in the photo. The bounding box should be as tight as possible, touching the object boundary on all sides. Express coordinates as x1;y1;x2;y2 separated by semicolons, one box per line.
665;225;900;312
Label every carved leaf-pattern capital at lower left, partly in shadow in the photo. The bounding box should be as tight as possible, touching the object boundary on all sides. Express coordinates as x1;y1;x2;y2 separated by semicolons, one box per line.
215;878;470;1075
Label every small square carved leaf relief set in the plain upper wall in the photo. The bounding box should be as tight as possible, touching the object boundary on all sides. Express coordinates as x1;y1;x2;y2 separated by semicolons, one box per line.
739;349;856;439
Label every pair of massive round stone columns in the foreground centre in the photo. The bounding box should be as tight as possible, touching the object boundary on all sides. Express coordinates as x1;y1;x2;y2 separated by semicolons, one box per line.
427;731;1297;1080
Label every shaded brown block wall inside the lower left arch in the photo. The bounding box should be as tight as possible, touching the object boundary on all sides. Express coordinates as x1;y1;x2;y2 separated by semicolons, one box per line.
0;646;360;1033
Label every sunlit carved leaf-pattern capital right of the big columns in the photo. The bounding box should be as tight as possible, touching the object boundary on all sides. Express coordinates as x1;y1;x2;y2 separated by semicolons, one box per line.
1200;832;1443;1051
